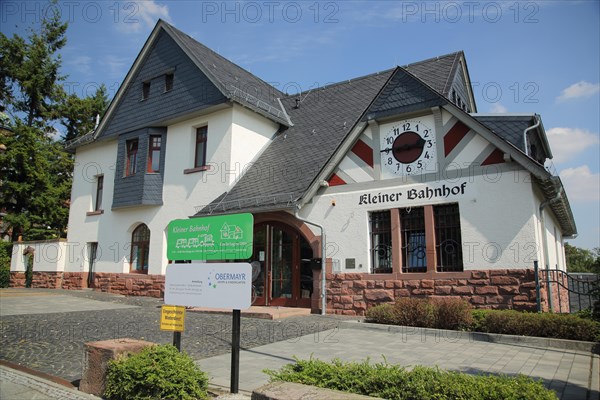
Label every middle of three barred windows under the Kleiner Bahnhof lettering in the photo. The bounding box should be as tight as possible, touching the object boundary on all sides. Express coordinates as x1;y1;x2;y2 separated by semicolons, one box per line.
400;207;427;272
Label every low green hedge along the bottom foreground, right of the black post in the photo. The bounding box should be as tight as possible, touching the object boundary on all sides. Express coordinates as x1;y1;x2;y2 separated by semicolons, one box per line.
264;357;557;400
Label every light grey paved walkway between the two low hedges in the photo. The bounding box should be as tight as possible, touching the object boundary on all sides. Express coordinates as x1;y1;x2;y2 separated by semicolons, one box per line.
197;328;600;400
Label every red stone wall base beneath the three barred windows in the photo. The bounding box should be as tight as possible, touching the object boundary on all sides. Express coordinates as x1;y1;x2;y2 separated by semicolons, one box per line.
326;269;548;315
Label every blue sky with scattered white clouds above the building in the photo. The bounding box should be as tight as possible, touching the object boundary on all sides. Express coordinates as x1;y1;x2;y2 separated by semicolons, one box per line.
0;0;600;248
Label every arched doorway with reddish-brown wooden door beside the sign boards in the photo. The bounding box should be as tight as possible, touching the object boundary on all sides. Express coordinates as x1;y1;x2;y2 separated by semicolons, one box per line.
251;222;313;307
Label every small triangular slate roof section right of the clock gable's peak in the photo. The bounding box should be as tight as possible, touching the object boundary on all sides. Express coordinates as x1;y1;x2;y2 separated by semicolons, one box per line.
404;51;463;97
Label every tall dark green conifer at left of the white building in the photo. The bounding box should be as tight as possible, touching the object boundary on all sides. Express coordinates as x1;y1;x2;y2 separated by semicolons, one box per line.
0;2;108;240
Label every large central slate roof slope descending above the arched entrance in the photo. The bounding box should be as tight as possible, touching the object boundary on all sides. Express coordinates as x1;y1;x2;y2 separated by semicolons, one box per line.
196;70;392;216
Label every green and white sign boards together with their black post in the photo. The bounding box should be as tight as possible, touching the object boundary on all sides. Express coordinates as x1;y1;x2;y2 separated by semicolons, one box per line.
165;213;254;393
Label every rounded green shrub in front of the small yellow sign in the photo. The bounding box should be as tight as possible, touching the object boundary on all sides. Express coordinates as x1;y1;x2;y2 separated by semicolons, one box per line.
104;345;208;400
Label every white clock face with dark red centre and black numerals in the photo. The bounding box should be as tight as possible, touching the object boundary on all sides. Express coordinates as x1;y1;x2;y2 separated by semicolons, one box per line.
381;119;437;175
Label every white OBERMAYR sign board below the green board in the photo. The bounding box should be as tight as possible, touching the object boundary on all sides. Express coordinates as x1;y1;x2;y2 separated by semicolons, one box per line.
165;263;252;310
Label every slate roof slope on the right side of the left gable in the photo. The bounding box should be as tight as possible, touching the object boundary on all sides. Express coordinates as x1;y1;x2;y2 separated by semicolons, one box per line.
162;21;289;125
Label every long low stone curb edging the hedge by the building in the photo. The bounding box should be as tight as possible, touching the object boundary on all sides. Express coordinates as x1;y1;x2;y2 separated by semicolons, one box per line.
339;321;600;354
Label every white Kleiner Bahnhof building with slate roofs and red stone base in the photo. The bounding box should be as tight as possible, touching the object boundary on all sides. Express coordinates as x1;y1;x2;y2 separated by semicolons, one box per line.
12;21;576;314
